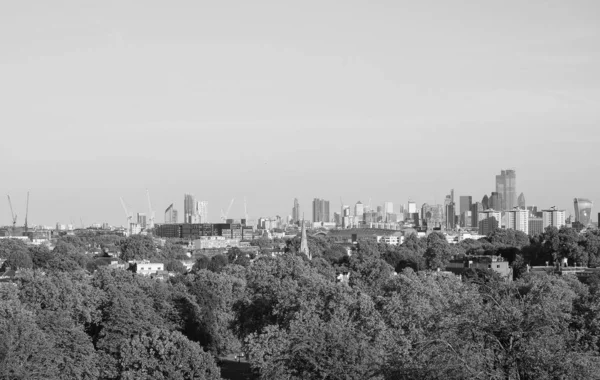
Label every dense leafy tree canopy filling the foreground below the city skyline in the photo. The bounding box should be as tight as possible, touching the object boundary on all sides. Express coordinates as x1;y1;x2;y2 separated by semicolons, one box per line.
0;228;600;379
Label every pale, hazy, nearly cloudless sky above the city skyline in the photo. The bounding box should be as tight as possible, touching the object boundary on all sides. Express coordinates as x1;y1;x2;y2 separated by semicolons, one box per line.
0;0;600;225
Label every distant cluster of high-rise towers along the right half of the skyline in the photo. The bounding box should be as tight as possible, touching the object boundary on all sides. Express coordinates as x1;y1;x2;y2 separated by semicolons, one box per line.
289;169;600;235
